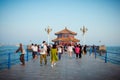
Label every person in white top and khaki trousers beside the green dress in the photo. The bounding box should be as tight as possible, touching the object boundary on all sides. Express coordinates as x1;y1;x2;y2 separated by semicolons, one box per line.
40;41;47;66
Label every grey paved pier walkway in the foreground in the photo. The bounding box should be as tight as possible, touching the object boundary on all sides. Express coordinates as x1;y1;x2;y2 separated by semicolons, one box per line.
0;54;120;80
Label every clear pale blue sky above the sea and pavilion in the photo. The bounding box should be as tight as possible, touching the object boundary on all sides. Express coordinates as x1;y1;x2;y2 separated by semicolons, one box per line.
0;0;120;46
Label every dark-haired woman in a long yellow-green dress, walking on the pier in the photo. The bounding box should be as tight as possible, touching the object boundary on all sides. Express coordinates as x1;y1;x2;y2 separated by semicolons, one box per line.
50;44;58;68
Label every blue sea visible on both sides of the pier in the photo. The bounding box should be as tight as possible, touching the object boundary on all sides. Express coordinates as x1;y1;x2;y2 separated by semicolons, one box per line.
0;45;120;70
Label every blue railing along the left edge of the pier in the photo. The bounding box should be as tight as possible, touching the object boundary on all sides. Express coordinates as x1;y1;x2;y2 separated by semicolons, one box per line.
0;50;32;70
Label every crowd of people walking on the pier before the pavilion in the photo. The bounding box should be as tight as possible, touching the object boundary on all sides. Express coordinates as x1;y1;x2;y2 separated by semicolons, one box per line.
16;41;87;67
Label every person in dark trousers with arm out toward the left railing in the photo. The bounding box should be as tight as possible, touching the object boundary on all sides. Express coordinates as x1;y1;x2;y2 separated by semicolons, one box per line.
16;43;25;66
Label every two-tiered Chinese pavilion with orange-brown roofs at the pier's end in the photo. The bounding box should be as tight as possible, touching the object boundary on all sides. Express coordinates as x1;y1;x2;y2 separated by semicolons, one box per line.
52;27;80;45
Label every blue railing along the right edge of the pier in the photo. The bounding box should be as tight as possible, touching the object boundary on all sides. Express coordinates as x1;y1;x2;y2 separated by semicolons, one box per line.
90;49;120;64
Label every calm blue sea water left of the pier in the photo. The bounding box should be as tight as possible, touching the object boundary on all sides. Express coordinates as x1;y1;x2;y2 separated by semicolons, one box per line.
0;46;32;70
